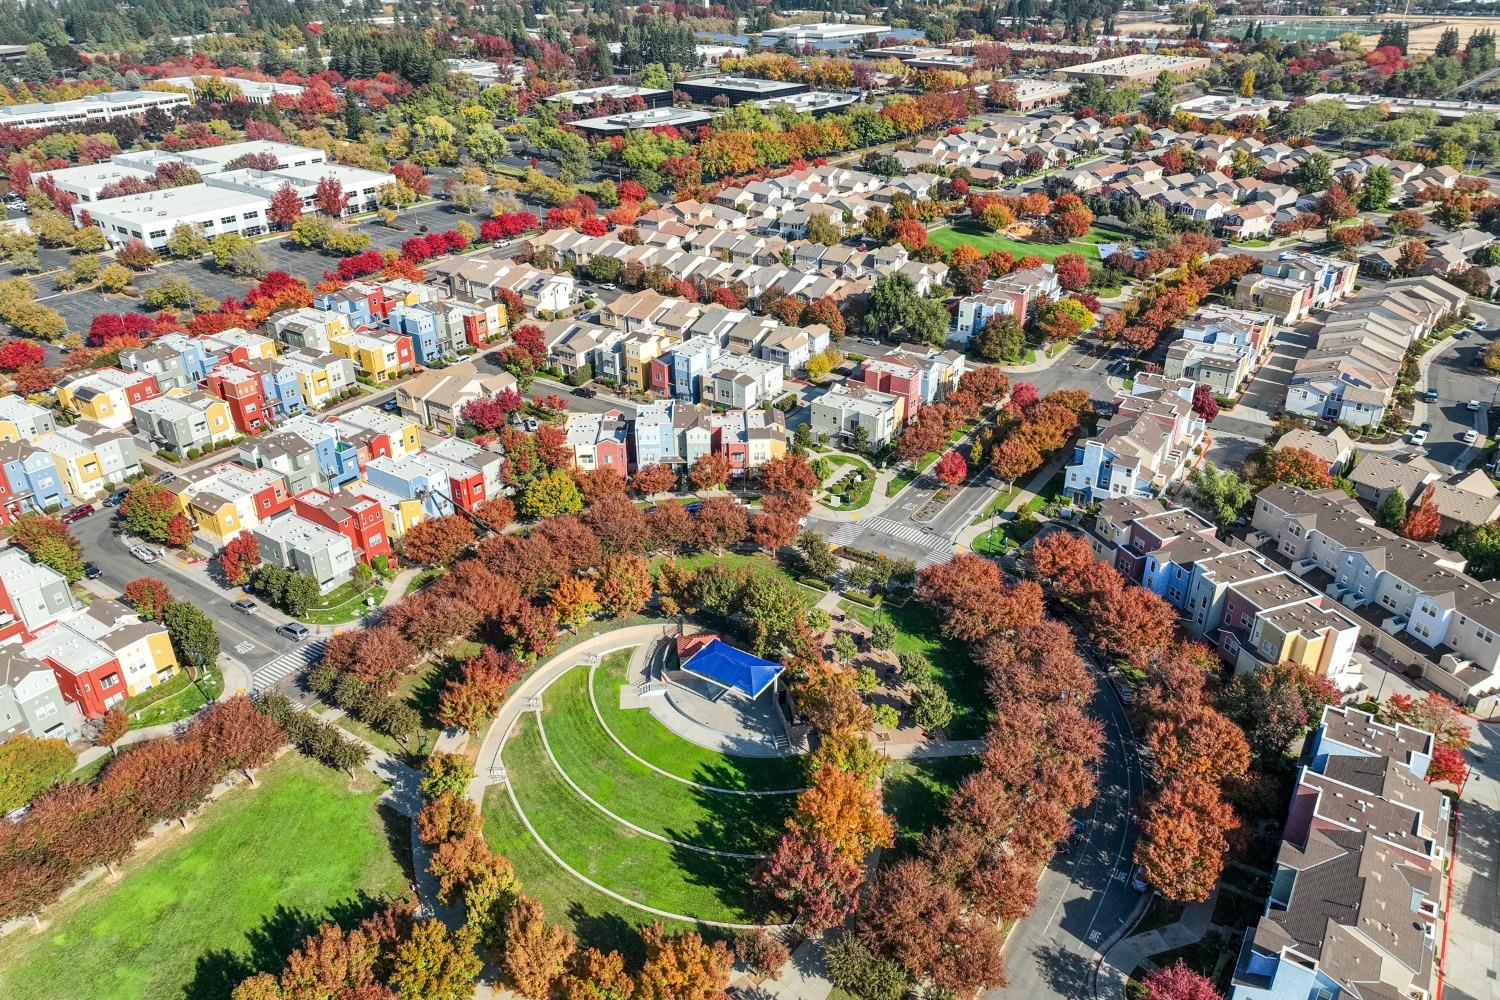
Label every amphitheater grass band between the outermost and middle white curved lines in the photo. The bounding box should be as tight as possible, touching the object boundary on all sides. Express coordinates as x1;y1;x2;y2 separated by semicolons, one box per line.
504;717;765;924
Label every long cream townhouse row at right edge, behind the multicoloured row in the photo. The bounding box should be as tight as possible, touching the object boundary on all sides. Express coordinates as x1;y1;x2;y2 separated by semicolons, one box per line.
1251;484;1500;711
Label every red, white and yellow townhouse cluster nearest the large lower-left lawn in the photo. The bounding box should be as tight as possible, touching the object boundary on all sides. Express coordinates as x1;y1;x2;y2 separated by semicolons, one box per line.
0;547;179;741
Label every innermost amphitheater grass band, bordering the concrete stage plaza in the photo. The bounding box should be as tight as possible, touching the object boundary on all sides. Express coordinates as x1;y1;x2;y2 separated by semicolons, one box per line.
594;649;807;792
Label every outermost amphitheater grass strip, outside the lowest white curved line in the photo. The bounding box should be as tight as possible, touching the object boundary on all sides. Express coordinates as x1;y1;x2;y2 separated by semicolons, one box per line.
485;786;713;963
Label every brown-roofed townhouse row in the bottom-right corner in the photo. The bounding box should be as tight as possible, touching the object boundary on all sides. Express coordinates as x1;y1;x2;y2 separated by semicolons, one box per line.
1229;706;1454;1000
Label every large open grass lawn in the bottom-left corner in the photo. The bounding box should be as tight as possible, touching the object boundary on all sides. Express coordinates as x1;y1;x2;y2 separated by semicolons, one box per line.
0;753;410;1000
